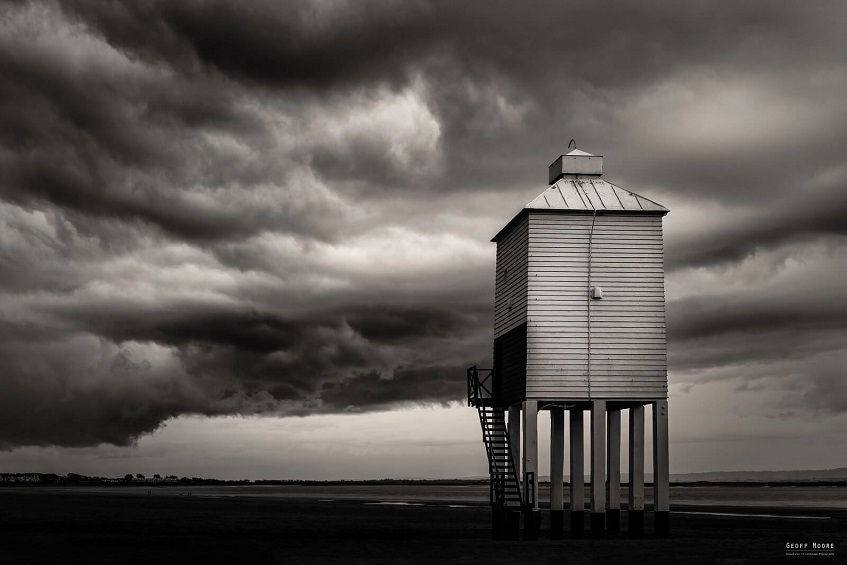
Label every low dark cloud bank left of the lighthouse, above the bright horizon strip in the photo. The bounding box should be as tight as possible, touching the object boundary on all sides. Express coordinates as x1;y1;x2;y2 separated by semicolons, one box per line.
0;296;479;449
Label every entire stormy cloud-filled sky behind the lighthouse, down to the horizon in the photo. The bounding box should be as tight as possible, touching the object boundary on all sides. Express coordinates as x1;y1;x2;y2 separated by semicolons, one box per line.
0;0;847;478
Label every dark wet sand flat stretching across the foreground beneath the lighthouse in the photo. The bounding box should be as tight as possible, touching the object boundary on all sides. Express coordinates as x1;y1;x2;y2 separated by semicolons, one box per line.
0;486;847;564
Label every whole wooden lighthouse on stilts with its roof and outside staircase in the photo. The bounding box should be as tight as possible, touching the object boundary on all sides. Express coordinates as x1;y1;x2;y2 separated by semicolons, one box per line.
468;144;670;539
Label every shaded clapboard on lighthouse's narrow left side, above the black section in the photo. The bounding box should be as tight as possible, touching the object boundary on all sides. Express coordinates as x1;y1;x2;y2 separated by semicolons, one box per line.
494;216;529;338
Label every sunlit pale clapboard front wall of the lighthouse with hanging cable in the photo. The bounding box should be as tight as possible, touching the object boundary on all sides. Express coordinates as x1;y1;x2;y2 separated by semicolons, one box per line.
528;212;667;400
